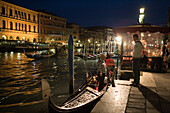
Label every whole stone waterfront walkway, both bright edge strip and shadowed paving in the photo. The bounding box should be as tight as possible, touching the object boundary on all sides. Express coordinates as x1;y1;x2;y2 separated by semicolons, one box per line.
91;72;170;113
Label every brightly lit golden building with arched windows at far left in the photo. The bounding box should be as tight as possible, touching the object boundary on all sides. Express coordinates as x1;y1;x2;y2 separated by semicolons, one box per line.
0;0;38;42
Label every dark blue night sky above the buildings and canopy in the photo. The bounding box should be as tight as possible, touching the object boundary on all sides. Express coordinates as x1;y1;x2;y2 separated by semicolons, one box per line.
5;0;170;28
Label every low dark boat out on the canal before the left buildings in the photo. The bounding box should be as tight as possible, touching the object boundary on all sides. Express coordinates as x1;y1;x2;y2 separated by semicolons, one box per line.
24;50;55;59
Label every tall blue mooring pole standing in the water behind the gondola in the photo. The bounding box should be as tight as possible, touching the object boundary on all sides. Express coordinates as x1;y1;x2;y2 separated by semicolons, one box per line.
68;35;74;94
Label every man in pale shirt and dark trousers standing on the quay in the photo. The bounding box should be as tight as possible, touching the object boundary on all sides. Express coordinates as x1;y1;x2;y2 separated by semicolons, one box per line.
132;34;144;86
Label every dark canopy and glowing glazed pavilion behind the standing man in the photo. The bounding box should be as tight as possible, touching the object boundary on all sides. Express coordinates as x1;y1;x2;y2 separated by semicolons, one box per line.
114;24;169;56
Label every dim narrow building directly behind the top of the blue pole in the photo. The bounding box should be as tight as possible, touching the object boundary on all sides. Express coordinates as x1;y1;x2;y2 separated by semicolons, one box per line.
66;23;80;46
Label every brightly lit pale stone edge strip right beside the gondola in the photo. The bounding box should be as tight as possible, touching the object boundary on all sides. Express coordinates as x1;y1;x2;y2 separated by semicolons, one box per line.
91;80;131;113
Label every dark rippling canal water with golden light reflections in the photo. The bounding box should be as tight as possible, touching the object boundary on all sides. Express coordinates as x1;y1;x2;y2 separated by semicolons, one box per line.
0;52;97;113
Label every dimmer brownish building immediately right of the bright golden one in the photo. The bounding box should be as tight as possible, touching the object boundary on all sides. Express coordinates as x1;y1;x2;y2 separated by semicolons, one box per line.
38;10;66;45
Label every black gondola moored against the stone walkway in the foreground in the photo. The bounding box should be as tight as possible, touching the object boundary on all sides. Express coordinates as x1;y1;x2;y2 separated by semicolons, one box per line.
41;77;108;113
